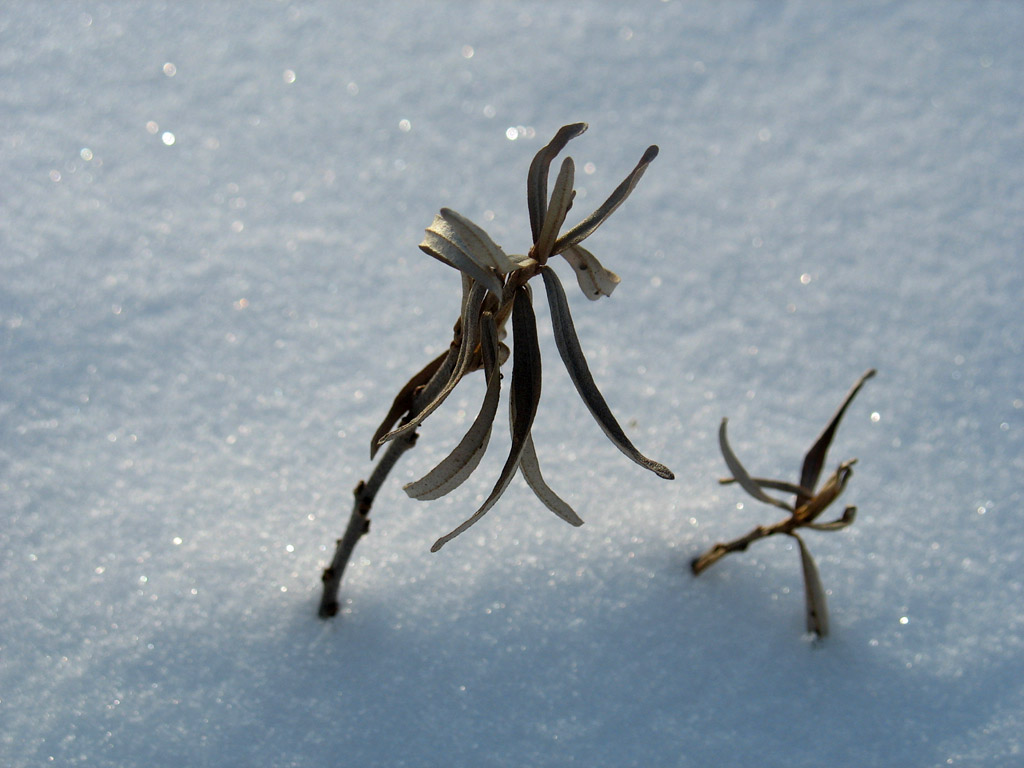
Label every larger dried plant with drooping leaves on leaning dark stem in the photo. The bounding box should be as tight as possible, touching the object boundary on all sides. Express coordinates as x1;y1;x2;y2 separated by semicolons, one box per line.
319;123;673;616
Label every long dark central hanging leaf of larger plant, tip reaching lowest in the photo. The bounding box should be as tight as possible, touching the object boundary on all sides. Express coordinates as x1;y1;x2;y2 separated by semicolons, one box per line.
430;286;541;552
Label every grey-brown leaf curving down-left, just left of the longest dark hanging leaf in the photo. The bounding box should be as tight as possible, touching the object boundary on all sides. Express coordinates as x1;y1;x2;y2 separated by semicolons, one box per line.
403;312;502;501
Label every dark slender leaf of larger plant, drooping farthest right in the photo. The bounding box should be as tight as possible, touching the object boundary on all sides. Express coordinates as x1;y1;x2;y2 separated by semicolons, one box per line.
541;267;675;480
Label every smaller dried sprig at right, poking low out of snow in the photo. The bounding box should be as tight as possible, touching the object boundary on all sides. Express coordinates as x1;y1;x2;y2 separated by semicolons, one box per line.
690;369;874;637
